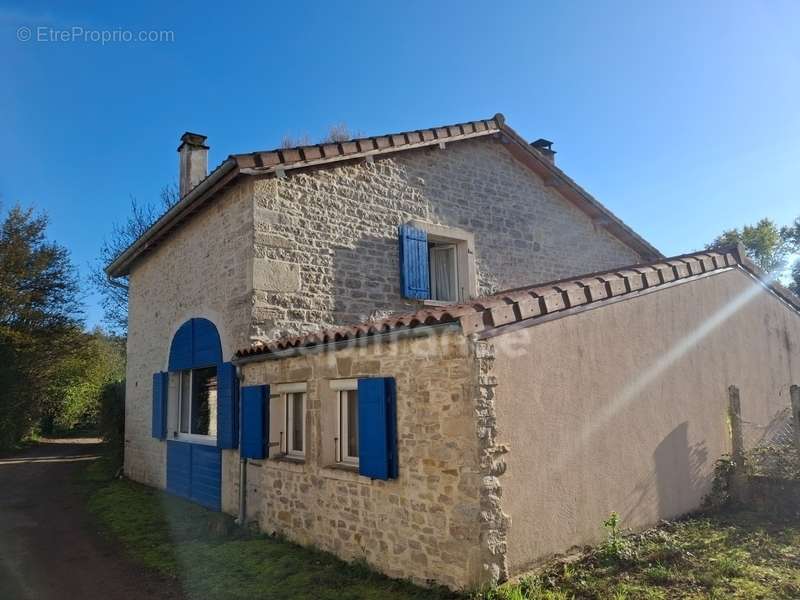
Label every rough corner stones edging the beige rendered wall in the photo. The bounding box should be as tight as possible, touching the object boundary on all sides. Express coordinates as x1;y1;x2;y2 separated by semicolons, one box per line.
472;340;511;583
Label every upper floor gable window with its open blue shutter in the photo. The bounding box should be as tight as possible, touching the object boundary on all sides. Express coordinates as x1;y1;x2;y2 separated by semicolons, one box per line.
400;222;477;303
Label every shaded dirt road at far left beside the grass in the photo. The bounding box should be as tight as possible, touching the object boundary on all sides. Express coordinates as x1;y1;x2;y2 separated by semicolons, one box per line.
0;439;181;600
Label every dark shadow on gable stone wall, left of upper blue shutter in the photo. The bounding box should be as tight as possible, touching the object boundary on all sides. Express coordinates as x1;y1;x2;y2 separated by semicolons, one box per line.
333;236;414;324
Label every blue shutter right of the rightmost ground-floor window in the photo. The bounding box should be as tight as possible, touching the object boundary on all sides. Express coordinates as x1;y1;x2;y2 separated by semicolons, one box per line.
358;377;398;479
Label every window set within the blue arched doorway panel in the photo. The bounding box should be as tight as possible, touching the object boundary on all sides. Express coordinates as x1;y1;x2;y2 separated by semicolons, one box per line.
178;367;217;438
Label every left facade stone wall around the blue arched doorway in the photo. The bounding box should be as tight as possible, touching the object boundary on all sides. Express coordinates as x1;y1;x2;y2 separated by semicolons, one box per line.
125;183;253;487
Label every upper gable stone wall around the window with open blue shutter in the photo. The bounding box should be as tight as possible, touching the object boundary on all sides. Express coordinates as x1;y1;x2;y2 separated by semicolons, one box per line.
251;139;639;339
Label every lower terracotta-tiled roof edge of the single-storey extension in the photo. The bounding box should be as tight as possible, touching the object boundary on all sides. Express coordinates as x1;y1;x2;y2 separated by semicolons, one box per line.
236;246;800;359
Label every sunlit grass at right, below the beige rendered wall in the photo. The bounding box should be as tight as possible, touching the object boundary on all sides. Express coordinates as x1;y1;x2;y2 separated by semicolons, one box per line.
475;511;800;600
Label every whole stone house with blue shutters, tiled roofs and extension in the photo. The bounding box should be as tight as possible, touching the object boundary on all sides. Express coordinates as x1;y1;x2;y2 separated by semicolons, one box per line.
107;115;800;588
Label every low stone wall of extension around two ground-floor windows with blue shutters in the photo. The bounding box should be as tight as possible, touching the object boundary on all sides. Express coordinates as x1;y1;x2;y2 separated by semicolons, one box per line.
238;333;485;588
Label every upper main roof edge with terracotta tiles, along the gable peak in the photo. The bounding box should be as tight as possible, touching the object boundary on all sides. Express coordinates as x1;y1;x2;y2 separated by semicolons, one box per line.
106;113;662;277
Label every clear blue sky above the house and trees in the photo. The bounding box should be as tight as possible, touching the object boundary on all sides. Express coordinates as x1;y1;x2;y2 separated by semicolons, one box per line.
0;0;800;325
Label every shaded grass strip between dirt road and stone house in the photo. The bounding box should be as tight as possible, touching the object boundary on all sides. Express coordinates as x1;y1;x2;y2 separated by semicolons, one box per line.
83;460;453;600
